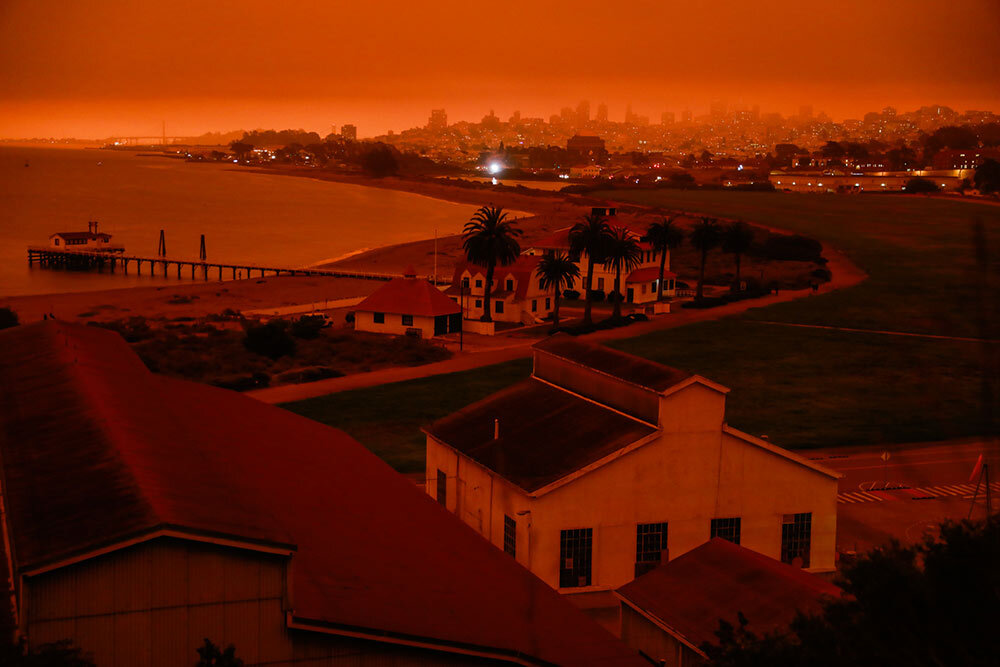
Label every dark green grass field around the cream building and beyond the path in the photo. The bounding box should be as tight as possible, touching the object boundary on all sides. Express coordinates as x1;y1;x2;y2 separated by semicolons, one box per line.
278;190;1000;471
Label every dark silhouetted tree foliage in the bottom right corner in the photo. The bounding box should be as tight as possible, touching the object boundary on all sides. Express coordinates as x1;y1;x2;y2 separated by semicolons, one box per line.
702;515;1000;667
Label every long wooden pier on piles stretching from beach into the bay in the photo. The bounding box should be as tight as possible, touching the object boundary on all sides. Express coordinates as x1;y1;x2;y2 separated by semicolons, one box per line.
28;246;418;280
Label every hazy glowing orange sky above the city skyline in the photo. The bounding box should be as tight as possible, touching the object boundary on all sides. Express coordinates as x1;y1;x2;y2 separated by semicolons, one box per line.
0;0;1000;137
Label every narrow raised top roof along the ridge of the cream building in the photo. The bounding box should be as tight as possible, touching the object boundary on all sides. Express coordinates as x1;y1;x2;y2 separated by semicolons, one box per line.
532;334;692;392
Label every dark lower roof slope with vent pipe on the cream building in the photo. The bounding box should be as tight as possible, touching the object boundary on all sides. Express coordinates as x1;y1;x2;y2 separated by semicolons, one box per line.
426;378;656;493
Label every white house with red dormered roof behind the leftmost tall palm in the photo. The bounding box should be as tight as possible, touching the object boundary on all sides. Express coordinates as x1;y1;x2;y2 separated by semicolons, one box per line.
445;255;555;324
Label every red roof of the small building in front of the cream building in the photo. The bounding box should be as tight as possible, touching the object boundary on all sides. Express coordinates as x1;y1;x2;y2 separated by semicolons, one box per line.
617;537;841;646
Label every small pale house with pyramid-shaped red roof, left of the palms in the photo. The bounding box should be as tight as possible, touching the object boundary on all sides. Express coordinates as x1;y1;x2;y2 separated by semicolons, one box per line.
354;267;462;338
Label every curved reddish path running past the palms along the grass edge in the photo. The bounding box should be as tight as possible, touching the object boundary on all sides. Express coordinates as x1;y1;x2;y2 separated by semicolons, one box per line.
246;237;868;403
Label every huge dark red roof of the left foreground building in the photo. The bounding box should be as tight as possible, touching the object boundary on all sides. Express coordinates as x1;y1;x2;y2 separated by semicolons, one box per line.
0;322;642;665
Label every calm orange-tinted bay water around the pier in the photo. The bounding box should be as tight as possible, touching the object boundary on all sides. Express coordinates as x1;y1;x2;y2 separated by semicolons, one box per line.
0;146;484;296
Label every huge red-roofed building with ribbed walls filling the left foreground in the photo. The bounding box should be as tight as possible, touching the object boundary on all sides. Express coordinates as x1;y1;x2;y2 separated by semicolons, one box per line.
0;321;645;667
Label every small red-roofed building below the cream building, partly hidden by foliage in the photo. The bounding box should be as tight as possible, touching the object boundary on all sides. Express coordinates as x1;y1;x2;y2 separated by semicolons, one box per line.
615;537;843;667
